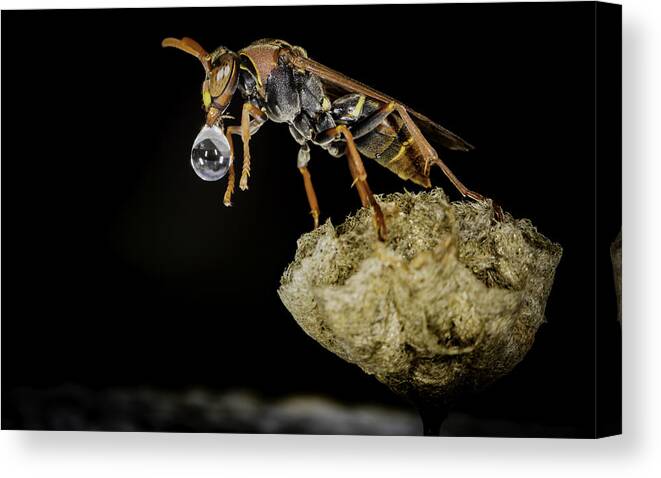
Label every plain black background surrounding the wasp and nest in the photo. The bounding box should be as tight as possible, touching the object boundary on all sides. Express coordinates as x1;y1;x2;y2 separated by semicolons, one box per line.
2;4;621;436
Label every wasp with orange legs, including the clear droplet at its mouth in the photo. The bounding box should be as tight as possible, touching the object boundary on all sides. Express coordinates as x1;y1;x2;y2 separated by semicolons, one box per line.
162;38;502;240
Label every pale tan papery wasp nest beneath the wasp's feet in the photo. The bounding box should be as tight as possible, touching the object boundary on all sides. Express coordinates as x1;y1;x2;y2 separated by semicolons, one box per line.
278;189;562;405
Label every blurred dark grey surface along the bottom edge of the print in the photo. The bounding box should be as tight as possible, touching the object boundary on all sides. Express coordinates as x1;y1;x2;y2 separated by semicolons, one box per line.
2;385;575;437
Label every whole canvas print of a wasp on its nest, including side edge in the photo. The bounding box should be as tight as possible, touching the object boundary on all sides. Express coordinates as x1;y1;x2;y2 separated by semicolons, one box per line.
2;2;622;438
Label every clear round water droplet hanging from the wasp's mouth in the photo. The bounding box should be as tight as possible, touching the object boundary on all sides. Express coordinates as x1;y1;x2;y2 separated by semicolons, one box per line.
191;125;231;181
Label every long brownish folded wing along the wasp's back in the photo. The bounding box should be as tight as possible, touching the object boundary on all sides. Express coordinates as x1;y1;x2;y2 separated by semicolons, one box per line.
291;56;473;151
